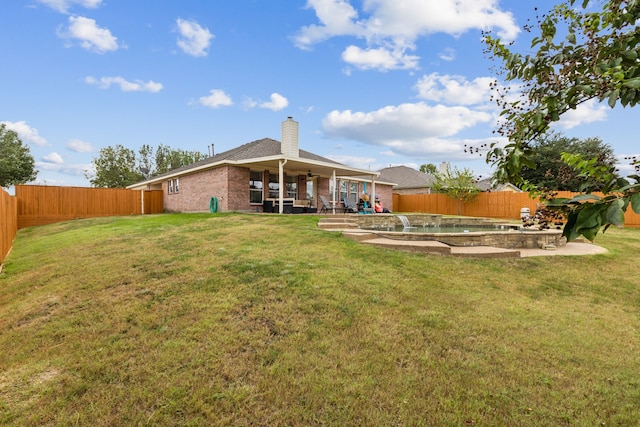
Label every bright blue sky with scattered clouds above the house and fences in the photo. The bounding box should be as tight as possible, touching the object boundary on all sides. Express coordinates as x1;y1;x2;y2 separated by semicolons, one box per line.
0;0;638;186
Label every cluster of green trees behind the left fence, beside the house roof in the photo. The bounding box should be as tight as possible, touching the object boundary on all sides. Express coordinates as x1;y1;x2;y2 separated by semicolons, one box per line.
85;144;206;188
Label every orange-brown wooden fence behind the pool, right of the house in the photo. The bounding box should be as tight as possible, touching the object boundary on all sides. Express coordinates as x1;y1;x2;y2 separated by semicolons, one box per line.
393;191;640;227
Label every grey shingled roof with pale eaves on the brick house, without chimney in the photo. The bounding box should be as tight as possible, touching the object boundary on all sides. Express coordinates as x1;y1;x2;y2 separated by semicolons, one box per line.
127;138;378;189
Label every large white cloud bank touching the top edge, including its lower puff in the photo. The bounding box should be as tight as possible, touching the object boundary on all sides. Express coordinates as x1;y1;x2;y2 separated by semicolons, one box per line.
293;0;520;69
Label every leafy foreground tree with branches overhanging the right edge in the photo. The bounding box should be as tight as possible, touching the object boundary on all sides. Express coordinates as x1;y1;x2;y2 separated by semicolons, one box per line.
485;0;640;240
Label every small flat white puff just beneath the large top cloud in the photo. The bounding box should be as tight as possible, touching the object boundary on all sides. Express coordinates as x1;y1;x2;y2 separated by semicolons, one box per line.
342;46;420;71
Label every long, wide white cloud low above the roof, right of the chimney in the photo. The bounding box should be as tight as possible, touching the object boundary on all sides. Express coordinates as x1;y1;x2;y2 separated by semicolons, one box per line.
323;103;492;158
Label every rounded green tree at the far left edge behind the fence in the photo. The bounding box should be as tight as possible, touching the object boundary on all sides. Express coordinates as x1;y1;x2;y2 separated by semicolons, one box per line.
0;123;38;187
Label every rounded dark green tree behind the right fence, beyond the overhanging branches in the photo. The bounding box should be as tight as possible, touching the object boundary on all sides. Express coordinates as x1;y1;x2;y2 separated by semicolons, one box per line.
521;132;616;192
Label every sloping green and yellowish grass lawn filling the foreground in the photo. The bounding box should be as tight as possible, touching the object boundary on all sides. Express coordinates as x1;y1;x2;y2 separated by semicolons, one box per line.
0;214;640;426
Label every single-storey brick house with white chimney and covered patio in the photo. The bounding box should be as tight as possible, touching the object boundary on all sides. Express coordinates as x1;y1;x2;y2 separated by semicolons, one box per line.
127;117;393;213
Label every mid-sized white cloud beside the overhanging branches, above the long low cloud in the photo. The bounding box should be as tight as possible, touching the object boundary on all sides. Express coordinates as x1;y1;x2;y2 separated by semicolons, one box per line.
415;73;495;105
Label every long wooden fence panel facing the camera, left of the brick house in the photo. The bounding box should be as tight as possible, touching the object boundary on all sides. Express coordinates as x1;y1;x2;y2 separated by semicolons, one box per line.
15;185;163;229
